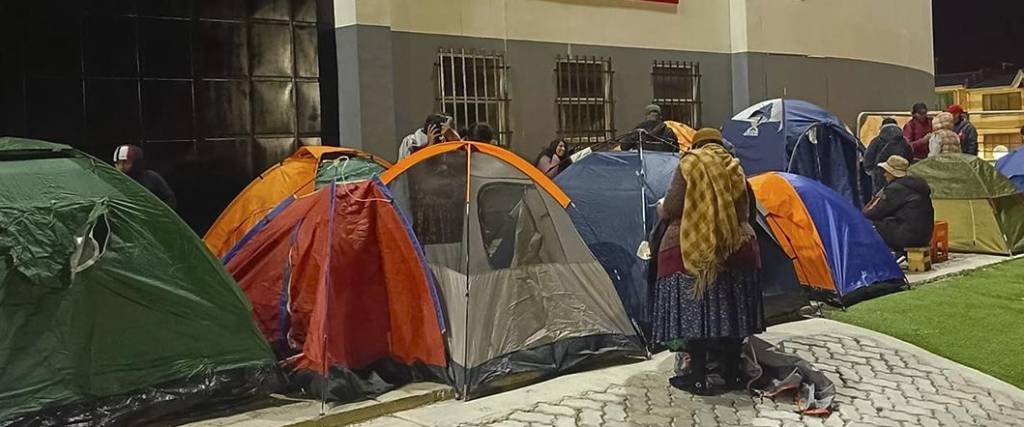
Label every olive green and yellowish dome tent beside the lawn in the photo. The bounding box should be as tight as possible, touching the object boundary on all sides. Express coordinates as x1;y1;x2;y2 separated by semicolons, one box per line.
910;154;1024;255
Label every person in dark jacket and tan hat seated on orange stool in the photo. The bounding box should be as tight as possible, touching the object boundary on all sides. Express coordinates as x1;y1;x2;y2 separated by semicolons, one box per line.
864;156;935;252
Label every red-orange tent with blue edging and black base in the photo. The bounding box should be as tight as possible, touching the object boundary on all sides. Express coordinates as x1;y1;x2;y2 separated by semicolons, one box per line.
224;178;447;401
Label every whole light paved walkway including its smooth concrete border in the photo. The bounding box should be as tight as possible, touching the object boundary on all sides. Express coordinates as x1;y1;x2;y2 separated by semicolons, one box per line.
364;319;1024;427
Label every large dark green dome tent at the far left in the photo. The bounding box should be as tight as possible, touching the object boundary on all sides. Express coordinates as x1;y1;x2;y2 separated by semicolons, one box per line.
0;138;279;425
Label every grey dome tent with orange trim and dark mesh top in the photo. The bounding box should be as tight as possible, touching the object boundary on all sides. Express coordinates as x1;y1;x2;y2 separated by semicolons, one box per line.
381;142;646;398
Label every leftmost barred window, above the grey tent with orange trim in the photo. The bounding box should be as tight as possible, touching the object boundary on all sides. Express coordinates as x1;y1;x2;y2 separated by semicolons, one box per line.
434;48;512;147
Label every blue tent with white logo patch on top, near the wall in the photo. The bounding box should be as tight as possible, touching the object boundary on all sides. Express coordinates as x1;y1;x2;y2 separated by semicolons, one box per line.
722;99;869;206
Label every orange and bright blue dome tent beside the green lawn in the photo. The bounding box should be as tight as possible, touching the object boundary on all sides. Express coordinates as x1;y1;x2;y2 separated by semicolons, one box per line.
750;172;906;305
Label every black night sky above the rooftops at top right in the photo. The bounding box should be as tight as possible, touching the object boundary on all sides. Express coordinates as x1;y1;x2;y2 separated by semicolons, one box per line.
932;0;1024;74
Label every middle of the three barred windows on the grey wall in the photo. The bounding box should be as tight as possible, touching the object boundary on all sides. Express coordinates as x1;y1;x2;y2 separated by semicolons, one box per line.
555;55;615;143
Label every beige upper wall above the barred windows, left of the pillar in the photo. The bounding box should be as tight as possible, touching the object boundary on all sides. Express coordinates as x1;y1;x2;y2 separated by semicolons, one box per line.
335;0;730;52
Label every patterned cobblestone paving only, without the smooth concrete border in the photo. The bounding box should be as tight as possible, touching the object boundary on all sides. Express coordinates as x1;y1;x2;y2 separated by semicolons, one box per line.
452;335;1024;427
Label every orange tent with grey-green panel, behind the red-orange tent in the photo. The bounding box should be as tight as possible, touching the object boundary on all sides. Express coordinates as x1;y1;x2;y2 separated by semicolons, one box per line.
203;145;391;258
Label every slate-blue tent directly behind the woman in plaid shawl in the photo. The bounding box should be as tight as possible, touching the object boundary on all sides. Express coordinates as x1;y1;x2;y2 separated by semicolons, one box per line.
555;152;807;332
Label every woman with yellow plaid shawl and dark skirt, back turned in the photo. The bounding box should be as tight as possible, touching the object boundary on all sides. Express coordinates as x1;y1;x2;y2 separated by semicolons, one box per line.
652;128;764;395
